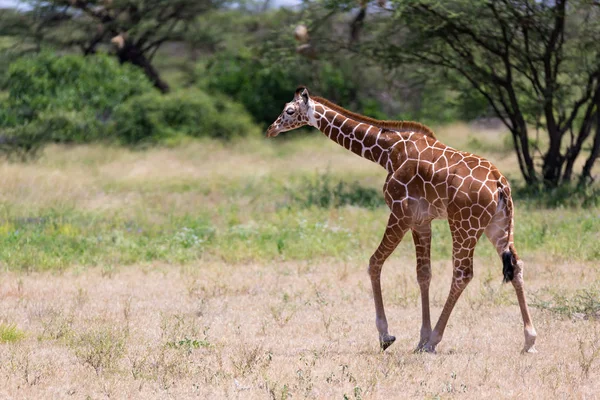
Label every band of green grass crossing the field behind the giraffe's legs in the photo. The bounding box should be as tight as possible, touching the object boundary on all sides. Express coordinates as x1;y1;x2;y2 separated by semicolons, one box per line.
0;188;600;271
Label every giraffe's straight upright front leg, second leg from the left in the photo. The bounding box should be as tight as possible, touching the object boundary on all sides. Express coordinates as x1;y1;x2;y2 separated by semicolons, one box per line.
412;223;431;352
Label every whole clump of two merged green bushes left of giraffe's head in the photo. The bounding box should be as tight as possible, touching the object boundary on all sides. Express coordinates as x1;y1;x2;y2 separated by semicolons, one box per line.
0;53;258;153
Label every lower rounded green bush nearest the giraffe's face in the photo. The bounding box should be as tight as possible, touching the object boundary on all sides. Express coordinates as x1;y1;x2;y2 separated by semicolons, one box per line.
112;90;258;144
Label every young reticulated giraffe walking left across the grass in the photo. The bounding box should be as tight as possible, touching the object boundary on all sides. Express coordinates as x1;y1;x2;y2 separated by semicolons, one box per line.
267;86;537;353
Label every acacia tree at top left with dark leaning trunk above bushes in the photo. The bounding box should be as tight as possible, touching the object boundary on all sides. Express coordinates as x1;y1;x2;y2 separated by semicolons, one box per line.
15;0;219;92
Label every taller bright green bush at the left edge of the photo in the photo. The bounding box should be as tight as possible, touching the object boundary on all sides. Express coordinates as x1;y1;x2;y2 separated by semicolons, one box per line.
0;53;154;155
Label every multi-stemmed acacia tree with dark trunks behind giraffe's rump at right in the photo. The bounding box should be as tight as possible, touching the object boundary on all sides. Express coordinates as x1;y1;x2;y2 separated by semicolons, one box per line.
304;0;600;187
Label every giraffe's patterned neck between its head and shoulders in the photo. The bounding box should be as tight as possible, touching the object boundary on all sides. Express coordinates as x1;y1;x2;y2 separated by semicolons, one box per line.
309;101;399;172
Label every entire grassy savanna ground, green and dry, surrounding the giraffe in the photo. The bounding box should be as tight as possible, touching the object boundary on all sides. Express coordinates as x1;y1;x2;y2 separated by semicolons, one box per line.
0;126;600;399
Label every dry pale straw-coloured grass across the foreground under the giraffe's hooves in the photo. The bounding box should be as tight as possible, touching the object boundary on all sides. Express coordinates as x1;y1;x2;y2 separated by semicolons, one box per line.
0;257;600;399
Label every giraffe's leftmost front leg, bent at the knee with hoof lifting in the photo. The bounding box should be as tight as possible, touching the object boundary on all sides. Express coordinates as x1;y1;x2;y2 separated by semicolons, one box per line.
369;214;406;351
